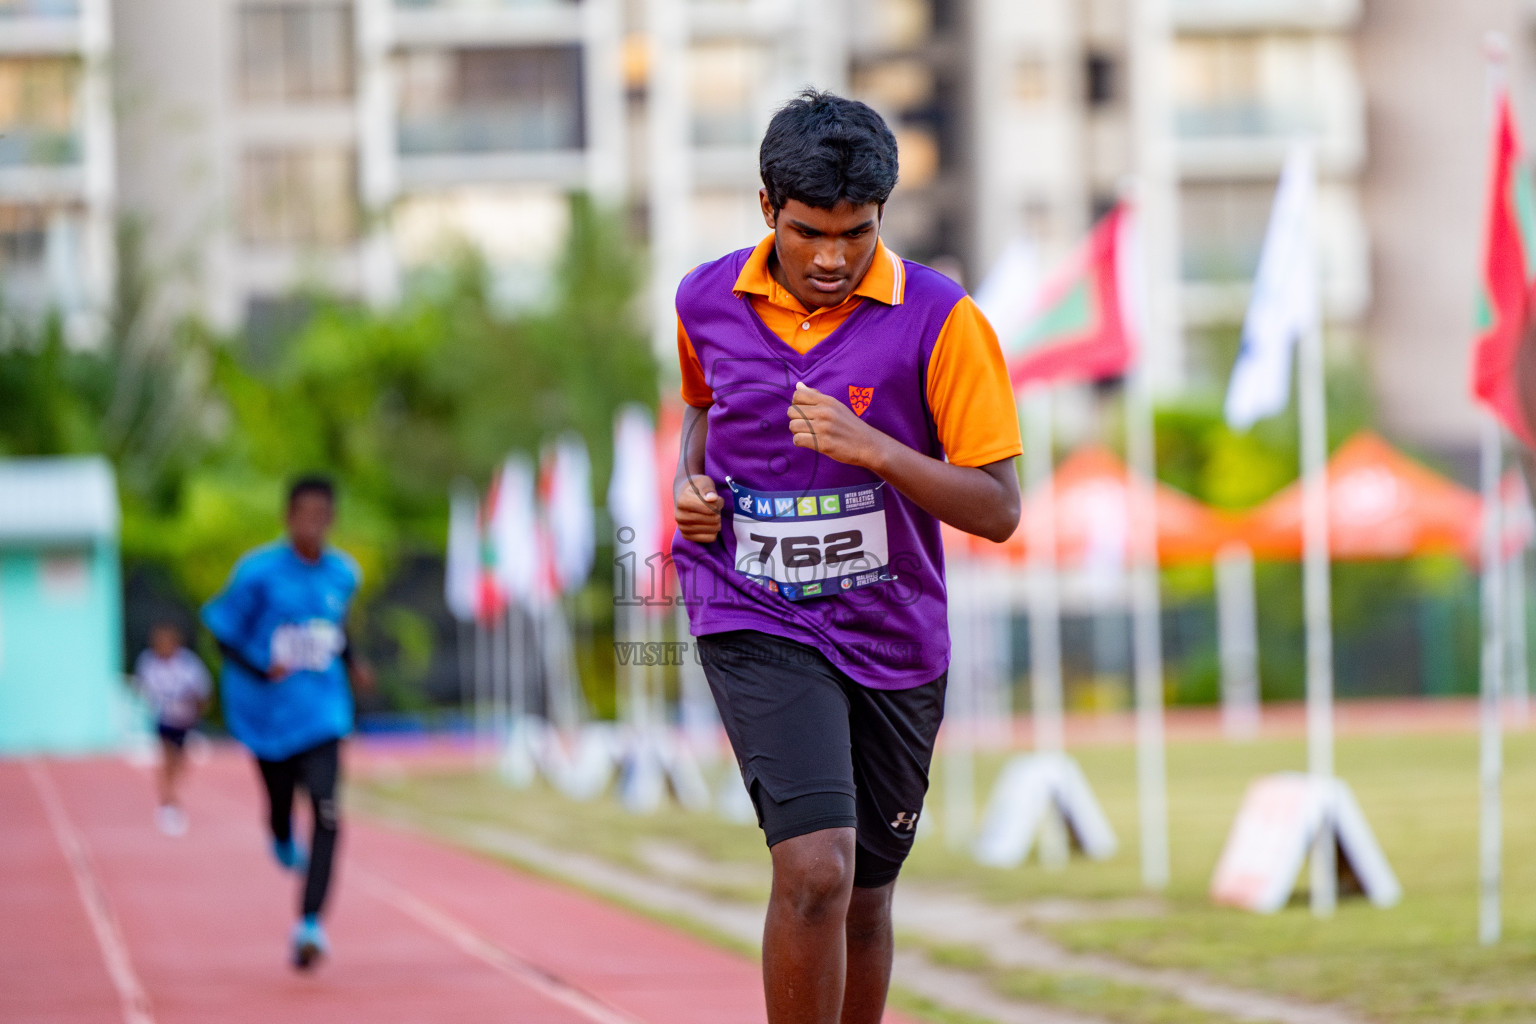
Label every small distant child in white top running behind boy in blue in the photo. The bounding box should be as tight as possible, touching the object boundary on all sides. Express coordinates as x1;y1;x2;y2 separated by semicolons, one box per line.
134;622;212;835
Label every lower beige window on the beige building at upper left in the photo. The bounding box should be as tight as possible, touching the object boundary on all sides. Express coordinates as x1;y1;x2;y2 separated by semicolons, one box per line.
240;146;358;246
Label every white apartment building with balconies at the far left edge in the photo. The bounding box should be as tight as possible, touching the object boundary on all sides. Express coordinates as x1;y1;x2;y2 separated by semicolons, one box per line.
0;0;117;342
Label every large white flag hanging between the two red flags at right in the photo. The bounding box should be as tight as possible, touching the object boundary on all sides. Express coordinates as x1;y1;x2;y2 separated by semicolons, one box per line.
1227;143;1322;430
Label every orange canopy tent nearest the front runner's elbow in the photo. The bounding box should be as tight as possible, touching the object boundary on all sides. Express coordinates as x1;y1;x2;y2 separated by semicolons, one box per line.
945;447;1232;565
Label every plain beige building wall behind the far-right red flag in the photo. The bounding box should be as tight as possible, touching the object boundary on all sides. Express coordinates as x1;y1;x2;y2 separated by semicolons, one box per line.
1358;0;1536;448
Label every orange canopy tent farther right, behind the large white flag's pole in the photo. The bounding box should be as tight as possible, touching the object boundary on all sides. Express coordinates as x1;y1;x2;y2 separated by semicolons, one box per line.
1238;431;1481;560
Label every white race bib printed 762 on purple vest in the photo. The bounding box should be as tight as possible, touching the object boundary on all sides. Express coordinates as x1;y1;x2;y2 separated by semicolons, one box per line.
727;479;894;600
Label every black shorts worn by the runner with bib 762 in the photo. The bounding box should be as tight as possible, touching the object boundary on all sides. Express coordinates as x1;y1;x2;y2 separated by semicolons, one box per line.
699;629;946;889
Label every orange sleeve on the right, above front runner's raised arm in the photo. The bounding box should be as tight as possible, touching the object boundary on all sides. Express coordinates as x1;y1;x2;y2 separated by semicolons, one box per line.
928;296;1023;467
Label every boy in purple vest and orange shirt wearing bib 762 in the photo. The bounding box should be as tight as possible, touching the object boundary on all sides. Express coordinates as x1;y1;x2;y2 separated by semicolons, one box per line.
673;91;1021;1024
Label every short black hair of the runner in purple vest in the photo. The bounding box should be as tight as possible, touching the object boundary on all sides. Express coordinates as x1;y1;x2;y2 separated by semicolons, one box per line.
757;89;897;212
